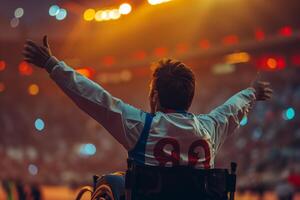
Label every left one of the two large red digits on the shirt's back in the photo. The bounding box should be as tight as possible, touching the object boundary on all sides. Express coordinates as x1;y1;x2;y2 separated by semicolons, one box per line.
154;138;180;167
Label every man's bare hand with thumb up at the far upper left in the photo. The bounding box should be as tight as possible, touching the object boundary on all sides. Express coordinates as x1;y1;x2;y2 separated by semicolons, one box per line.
23;35;52;68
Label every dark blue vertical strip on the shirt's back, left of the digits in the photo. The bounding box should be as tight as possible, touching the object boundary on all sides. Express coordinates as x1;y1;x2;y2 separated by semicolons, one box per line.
128;113;153;165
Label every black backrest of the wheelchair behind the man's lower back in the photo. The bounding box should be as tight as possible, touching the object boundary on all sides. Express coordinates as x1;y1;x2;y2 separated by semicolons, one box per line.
125;161;236;200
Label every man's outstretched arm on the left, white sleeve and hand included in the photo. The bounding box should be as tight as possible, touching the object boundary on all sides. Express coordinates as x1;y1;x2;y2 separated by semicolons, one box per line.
23;36;145;149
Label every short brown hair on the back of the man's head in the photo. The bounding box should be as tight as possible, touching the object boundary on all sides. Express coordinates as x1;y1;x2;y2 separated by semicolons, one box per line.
152;58;195;111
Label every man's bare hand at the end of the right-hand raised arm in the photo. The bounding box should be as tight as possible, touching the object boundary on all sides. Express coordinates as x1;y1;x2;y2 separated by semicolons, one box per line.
251;74;273;101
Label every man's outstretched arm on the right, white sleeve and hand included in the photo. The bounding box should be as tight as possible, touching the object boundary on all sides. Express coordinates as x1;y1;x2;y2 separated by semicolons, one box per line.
200;76;273;150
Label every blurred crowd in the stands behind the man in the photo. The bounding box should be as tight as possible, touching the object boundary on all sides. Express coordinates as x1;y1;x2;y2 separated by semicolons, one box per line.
0;56;300;198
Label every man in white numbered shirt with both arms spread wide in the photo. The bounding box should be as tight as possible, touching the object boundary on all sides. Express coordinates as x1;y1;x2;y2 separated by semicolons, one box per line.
23;36;272;169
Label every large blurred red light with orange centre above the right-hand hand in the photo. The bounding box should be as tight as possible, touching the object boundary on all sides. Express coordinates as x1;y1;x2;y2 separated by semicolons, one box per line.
257;56;286;71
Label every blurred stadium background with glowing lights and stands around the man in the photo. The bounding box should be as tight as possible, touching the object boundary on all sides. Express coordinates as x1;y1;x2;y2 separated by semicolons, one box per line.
0;0;300;200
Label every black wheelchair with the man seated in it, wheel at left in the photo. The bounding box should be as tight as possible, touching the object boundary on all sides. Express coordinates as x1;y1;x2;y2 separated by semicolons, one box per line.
76;160;237;200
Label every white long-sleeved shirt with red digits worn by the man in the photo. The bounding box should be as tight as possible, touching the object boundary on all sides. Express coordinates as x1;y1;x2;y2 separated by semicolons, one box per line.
46;57;255;168
